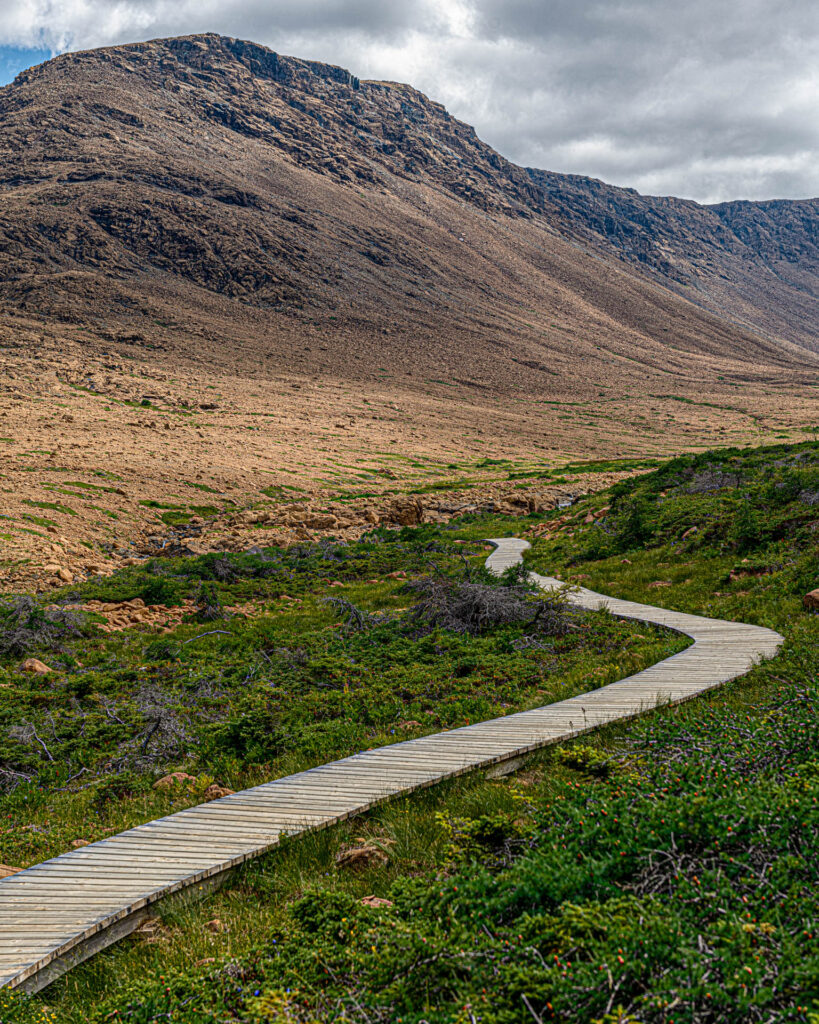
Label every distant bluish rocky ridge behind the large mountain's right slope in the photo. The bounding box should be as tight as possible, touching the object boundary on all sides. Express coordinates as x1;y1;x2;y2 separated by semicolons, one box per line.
528;169;819;350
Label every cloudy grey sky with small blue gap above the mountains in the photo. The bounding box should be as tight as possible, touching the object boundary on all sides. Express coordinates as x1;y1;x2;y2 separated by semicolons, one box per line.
0;0;819;202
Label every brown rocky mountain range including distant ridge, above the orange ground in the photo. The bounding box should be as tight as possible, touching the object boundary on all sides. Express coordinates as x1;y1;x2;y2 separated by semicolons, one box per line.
0;35;819;390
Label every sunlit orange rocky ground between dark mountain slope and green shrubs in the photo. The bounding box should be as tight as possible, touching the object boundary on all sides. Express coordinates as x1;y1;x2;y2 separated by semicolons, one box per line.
0;323;816;590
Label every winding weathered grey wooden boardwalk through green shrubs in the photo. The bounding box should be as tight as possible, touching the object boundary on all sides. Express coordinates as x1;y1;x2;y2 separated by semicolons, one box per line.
0;539;782;991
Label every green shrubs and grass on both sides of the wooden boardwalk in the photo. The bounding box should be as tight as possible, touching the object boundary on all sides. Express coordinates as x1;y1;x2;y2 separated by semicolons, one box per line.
0;443;819;1024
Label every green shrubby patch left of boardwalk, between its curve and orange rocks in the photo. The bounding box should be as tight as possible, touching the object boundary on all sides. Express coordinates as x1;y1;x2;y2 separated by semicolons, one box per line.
0;519;685;880
